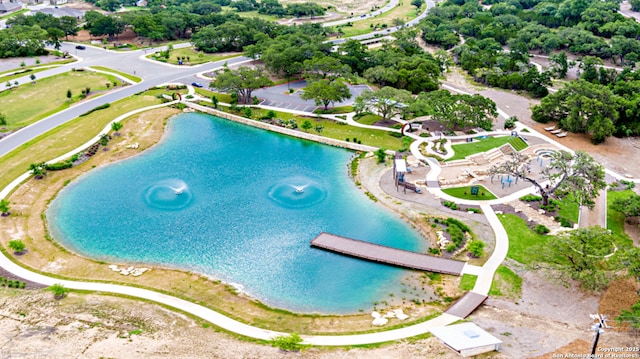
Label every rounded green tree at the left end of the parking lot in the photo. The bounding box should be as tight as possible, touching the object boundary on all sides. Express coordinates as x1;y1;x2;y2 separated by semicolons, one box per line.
209;66;273;104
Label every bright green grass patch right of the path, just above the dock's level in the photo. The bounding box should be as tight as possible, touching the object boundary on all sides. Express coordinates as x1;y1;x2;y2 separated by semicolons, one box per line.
498;214;551;264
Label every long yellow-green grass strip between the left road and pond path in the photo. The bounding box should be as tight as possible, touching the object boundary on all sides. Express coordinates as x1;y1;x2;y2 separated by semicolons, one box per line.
0;94;161;188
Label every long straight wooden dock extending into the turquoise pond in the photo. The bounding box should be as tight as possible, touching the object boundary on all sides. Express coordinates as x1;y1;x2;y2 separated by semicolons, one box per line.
311;232;465;275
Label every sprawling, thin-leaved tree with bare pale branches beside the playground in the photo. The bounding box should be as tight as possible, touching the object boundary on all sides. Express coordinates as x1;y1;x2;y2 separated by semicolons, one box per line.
489;151;607;208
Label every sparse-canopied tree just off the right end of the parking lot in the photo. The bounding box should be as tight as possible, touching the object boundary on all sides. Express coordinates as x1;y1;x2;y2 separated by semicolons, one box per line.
355;86;413;121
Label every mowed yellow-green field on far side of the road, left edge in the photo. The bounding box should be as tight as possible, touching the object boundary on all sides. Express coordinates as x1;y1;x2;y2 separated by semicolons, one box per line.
0;71;120;128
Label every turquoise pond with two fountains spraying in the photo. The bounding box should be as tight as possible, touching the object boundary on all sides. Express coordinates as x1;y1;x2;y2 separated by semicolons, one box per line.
47;113;426;313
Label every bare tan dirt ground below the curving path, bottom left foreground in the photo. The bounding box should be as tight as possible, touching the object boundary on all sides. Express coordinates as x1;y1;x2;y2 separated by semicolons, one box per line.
0;290;468;359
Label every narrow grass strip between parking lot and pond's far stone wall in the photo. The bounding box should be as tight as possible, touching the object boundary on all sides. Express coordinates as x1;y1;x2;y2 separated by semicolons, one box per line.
200;101;402;150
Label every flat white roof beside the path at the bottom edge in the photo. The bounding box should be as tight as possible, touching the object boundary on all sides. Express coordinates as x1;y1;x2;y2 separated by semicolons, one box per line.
431;323;502;351
